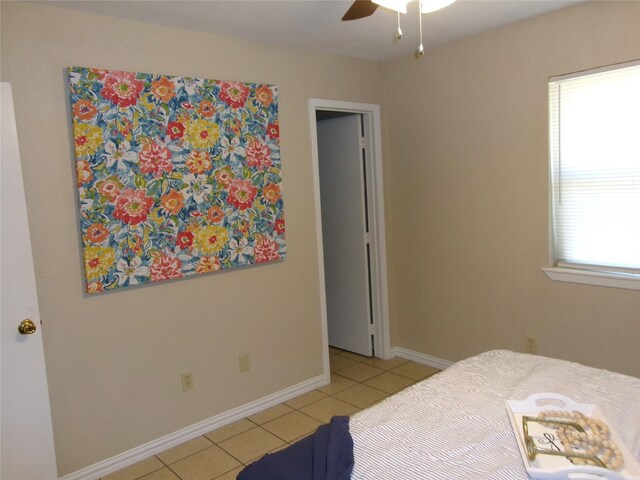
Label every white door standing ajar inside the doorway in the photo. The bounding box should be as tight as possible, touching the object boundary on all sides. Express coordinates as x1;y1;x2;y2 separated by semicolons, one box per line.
317;114;372;356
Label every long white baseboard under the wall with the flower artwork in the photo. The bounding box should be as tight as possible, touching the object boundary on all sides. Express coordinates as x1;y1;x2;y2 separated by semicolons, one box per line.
60;373;331;480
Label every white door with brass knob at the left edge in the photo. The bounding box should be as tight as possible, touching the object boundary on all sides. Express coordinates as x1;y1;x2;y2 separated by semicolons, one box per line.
0;82;58;480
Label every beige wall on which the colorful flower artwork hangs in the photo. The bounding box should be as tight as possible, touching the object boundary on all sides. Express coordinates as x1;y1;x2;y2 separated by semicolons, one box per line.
1;1;383;475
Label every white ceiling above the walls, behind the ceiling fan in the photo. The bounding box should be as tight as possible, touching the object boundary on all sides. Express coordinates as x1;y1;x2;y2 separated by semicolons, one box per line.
39;0;584;61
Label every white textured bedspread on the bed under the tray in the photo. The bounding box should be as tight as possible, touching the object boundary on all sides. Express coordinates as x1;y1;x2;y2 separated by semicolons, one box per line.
350;350;640;480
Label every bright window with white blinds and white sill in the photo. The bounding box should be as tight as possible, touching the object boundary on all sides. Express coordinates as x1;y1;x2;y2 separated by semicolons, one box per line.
545;61;640;289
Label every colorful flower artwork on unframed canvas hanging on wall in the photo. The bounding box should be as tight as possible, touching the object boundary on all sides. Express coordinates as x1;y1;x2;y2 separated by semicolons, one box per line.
69;67;286;293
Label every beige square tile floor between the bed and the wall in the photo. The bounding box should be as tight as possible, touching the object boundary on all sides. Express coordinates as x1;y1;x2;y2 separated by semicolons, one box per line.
102;347;438;480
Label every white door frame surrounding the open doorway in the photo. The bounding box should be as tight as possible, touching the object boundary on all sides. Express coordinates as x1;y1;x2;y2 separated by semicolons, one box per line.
309;98;391;376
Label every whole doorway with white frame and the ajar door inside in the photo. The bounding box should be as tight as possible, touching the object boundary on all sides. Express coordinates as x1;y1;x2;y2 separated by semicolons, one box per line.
309;99;390;372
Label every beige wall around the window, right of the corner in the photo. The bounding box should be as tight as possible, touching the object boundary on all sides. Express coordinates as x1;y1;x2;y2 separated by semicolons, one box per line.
385;1;640;376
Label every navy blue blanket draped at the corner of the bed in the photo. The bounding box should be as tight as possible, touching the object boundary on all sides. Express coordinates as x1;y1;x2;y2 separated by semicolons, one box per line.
236;417;353;480
